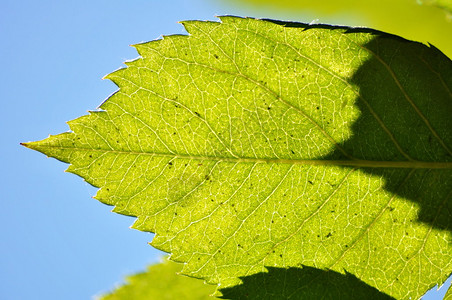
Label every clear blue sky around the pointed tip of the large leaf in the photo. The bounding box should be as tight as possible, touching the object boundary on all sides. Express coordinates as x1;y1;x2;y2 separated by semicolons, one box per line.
0;0;448;300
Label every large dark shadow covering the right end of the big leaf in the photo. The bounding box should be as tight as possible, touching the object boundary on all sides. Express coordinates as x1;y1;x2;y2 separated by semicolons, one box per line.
274;20;452;231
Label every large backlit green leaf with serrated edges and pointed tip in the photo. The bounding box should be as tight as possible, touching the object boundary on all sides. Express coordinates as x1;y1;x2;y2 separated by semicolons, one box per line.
26;17;452;299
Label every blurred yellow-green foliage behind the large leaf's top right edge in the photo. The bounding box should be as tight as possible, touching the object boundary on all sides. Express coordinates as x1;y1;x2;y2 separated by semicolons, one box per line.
223;0;452;57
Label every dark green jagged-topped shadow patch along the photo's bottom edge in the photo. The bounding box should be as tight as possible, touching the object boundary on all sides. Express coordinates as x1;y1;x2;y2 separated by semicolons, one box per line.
220;266;394;299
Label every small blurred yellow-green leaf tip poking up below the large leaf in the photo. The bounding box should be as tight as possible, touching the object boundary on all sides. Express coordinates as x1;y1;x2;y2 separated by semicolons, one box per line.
100;260;215;300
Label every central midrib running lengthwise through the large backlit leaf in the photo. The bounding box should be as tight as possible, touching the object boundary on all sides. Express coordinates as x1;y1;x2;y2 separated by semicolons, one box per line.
33;144;452;169
